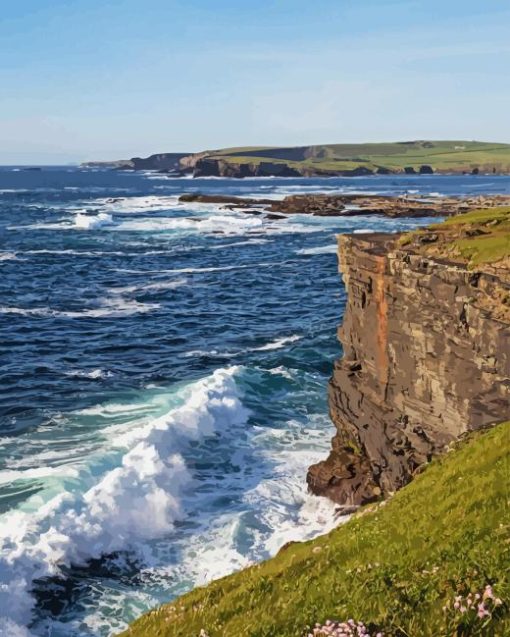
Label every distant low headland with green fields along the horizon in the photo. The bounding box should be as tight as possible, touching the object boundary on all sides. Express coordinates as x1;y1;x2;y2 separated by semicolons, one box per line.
82;140;510;177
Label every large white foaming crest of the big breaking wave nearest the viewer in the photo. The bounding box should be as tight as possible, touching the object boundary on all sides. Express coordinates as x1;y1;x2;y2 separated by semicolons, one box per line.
0;368;248;636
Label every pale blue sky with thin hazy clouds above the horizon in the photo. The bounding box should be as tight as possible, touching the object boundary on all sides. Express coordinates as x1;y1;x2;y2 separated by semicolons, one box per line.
0;0;510;164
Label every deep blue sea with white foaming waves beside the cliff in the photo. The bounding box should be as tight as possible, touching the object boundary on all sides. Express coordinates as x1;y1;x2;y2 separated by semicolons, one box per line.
0;167;510;637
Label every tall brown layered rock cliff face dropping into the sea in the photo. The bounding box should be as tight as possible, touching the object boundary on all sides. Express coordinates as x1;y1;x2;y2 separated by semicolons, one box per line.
307;234;510;505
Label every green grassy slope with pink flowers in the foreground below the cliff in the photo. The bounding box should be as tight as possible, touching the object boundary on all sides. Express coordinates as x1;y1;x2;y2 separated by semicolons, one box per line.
123;422;510;637
